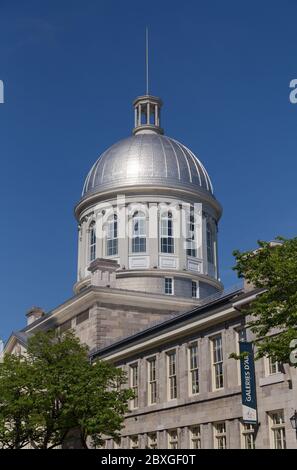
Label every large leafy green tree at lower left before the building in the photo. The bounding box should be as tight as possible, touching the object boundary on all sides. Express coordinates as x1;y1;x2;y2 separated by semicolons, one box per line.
0;331;133;449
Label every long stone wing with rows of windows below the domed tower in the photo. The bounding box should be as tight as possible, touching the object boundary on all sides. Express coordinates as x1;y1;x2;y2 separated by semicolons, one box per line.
93;289;297;449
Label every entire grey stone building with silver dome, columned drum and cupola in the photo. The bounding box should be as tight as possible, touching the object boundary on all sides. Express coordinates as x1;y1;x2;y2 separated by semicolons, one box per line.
5;95;297;449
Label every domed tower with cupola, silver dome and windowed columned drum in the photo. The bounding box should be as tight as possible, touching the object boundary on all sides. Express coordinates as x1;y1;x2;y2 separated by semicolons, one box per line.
75;95;222;302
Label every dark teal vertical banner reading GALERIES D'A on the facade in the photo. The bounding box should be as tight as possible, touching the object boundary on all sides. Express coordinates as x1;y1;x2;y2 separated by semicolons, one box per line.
239;341;257;424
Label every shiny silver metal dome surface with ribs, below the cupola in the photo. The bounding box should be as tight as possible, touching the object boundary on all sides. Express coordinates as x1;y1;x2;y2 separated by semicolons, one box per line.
82;133;213;197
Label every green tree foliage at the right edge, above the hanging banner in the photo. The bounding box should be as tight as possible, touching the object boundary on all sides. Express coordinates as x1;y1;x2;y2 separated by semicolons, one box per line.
233;237;297;366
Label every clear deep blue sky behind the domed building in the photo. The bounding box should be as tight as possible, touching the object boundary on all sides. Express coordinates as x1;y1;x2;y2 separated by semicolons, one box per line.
0;0;297;339
